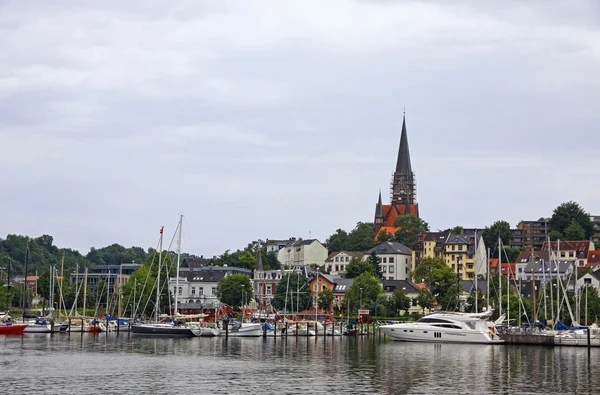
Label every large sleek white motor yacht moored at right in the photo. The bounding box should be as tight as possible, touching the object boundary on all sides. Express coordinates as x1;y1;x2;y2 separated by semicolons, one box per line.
379;312;504;343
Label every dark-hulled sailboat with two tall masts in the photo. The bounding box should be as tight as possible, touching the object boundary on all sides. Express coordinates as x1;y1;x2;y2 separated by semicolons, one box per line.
131;215;201;337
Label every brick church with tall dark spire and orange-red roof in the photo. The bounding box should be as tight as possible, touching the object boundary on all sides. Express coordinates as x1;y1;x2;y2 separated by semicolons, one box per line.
373;117;419;238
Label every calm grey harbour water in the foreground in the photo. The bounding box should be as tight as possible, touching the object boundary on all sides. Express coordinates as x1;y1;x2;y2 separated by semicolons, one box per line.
0;333;600;394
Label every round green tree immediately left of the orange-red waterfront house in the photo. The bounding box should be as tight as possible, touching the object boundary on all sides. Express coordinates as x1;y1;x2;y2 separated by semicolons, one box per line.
271;273;312;312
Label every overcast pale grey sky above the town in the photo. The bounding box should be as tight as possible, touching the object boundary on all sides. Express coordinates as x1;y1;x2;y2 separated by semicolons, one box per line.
0;0;600;256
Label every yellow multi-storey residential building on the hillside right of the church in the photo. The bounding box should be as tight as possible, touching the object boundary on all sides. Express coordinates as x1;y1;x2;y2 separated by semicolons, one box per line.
444;233;475;280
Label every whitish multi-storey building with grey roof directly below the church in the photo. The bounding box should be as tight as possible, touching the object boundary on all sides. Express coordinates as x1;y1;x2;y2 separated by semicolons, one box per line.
363;241;412;280
